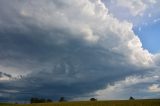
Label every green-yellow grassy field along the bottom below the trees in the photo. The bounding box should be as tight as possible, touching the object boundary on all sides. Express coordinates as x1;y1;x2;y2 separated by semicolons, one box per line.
0;100;160;106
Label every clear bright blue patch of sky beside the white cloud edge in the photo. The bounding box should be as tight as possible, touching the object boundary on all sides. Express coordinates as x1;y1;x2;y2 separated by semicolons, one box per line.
134;22;160;54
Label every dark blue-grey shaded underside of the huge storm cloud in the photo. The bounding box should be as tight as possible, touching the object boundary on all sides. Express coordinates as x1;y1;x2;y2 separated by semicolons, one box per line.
1;31;146;99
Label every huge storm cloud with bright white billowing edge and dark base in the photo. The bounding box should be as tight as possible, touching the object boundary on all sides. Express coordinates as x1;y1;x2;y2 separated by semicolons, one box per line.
0;0;158;100
